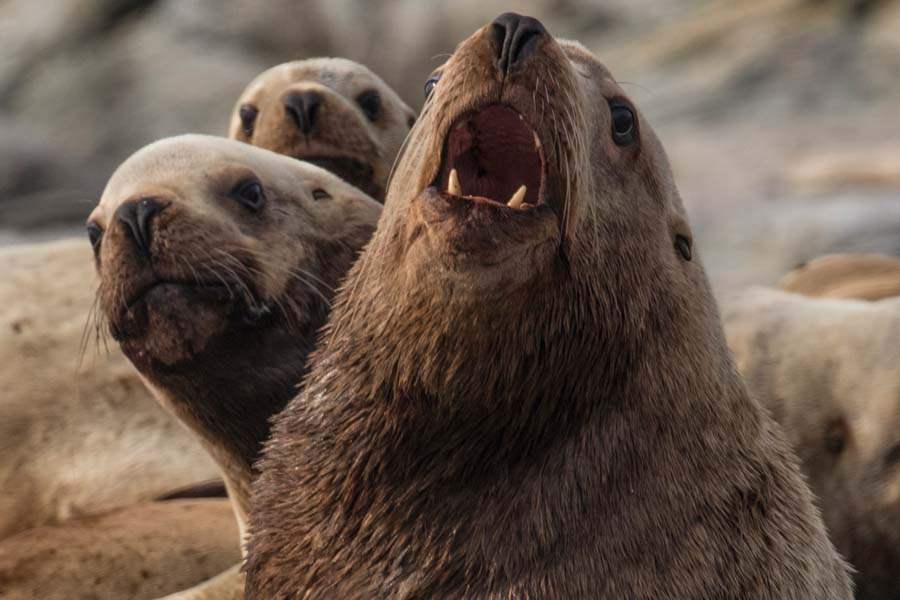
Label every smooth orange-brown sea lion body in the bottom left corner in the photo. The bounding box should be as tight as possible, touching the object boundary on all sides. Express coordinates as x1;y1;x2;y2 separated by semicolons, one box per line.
0;500;240;600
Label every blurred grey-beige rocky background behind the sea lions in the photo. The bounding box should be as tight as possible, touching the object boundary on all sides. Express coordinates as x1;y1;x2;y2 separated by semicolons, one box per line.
0;0;900;290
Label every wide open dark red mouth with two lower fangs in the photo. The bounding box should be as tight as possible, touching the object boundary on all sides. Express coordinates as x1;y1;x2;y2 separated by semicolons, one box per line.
435;104;544;210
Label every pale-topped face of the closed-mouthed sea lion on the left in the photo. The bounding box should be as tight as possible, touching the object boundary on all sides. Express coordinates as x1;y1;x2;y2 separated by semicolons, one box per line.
88;136;380;371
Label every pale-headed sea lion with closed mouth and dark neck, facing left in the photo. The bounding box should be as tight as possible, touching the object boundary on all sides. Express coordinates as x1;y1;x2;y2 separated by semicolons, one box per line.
88;135;381;596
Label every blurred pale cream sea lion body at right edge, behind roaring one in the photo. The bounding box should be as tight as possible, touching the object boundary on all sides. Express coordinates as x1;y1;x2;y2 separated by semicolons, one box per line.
723;288;900;600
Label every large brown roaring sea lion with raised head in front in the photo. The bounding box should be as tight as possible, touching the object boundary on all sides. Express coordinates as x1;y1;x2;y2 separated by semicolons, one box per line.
245;13;851;599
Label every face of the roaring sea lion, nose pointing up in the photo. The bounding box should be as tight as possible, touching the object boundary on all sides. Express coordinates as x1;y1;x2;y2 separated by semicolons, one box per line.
385;14;691;294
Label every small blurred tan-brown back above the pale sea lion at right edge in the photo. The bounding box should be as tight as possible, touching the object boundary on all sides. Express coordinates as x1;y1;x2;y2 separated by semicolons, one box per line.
778;253;900;300
